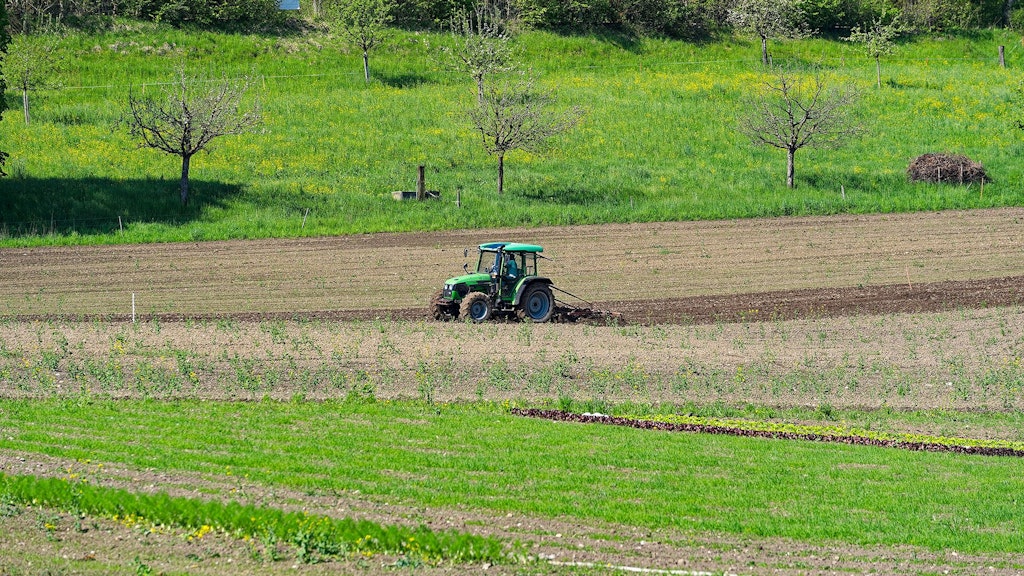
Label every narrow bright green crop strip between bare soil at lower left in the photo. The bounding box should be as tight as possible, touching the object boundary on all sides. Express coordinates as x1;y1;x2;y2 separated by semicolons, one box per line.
0;475;511;563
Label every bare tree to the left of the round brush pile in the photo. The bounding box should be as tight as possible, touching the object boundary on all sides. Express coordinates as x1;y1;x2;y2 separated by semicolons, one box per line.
739;71;861;188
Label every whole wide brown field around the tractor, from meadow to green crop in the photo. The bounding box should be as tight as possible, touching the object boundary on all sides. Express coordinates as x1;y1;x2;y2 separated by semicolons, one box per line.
0;208;1024;422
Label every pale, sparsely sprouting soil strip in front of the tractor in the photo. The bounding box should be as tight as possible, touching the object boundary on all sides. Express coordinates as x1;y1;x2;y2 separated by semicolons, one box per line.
6;306;1024;426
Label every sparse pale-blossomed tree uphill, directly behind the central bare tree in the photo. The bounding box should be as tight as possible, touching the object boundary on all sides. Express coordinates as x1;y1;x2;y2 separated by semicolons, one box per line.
440;0;520;102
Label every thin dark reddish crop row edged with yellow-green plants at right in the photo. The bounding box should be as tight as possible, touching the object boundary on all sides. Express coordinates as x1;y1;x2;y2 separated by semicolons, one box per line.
511;408;1024;457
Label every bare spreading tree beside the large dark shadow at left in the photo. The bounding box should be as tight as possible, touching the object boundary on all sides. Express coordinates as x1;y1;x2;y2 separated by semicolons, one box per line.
124;70;262;205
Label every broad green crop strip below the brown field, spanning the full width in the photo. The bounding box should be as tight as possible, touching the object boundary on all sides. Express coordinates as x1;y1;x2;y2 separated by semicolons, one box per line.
0;400;1024;552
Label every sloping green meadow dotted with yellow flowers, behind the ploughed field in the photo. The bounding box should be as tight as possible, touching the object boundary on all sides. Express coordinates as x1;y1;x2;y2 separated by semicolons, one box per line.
6;23;1024;246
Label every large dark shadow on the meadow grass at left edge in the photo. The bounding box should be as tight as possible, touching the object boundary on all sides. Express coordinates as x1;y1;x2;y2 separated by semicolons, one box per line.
0;177;241;238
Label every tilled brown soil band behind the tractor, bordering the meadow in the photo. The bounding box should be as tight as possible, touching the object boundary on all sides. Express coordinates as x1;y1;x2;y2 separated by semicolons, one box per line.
0;208;1024;323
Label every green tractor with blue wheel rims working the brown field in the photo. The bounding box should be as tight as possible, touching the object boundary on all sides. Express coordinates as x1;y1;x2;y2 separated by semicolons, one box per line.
430;242;555;322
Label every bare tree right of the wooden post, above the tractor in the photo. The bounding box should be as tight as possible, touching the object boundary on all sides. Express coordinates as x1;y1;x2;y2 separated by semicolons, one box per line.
469;74;583;194
